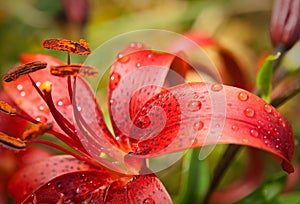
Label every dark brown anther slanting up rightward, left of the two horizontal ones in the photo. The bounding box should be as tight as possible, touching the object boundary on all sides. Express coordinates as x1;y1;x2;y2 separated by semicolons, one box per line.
3;61;47;82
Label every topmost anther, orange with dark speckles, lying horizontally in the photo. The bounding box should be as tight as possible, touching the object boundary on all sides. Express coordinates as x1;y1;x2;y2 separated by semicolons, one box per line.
42;38;91;55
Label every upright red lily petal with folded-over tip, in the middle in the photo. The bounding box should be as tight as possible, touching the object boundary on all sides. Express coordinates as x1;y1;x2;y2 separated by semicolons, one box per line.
108;44;186;151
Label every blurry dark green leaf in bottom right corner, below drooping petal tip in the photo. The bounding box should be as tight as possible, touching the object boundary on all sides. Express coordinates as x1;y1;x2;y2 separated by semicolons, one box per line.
236;173;287;204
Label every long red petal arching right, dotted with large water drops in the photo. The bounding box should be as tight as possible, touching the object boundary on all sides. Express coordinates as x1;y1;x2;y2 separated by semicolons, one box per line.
134;83;294;172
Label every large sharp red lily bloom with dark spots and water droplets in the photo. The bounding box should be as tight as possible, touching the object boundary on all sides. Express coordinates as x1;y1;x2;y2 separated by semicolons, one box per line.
3;39;294;203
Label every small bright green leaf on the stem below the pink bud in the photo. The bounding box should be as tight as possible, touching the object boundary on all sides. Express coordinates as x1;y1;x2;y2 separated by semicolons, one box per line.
256;54;280;103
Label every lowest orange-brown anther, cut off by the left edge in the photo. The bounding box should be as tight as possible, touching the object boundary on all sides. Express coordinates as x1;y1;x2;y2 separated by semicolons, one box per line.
0;132;26;151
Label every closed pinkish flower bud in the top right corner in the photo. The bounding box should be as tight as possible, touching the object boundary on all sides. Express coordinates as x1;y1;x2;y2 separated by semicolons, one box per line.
270;0;300;50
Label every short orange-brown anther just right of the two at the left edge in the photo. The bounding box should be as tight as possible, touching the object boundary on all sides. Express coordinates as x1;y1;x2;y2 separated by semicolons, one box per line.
22;123;53;140
